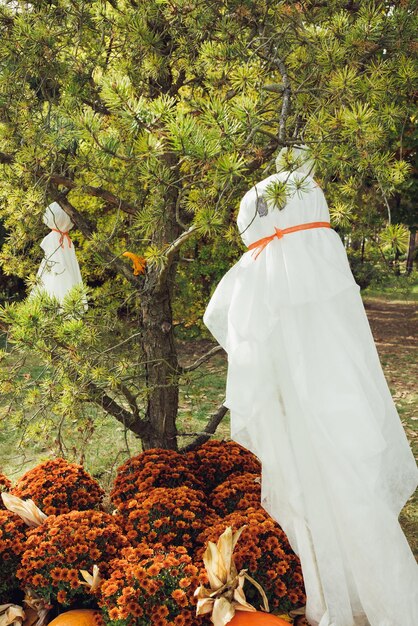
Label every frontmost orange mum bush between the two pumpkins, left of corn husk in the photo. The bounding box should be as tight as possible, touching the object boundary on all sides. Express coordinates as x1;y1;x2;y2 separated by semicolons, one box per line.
99;544;209;626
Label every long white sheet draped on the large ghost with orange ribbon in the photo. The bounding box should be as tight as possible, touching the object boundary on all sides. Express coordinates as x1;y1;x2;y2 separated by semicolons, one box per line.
204;172;418;626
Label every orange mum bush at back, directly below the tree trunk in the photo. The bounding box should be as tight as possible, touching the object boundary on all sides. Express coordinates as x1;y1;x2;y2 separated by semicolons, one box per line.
110;448;202;505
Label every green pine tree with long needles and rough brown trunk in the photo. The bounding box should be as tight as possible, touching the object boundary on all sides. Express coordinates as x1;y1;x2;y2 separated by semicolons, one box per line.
0;0;417;448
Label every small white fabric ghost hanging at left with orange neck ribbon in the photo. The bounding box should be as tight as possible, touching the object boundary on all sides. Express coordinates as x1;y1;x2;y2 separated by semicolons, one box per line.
35;202;83;302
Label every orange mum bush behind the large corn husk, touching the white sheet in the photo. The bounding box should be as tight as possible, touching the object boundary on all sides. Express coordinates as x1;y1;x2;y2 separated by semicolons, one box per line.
195;508;306;613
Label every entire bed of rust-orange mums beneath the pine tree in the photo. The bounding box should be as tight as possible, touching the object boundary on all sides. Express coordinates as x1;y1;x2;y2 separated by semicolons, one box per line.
0;450;306;626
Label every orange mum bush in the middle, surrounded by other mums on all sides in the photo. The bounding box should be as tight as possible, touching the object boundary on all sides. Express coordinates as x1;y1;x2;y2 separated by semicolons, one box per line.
116;487;217;548
